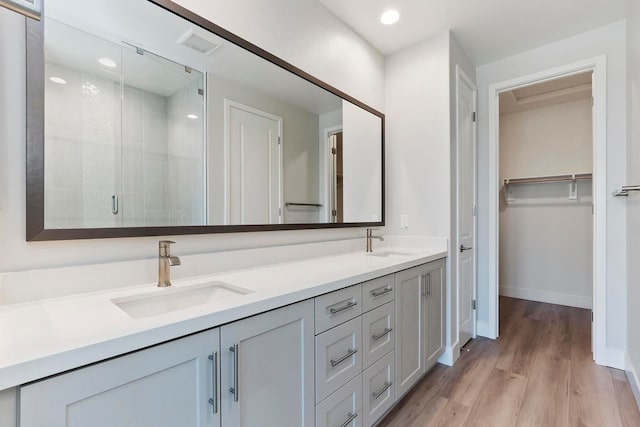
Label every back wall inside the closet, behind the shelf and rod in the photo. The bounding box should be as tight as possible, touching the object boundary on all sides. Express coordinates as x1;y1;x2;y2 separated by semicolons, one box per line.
499;99;593;308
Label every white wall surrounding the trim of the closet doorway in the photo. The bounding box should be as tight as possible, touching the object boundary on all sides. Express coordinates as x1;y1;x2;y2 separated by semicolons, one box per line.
476;21;627;361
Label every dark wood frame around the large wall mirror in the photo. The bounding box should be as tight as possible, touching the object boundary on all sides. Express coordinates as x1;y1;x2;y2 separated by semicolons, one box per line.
26;0;385;241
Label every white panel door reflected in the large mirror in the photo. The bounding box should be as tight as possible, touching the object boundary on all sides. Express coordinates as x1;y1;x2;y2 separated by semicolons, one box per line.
226;100;282;224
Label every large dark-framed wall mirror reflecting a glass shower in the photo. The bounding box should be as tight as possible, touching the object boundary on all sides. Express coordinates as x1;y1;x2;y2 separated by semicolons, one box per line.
27;0;384;240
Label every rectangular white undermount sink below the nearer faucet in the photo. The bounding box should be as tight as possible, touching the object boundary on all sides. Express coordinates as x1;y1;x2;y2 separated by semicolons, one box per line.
111;282;253;319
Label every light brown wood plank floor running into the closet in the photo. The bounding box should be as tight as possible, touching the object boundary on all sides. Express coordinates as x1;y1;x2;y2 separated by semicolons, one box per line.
379;297;640;427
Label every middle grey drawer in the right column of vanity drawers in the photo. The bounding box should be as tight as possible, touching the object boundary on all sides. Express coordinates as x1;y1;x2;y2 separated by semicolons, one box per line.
362;302;396;368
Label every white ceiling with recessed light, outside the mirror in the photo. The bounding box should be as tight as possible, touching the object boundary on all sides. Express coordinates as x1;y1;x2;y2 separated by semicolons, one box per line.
317;0;638;65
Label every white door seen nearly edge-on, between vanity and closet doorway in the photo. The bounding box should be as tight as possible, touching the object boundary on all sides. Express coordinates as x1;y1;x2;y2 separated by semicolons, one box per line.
456;68;476;347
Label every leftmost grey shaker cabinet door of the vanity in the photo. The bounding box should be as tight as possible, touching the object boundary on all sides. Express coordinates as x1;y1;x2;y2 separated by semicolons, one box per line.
19;329;220;427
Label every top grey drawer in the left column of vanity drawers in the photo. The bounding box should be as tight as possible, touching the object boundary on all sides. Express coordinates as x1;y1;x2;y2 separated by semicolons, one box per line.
315;285;362;334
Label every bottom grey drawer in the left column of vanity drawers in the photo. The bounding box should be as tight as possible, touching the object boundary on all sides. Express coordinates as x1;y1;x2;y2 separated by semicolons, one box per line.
316;375;362;427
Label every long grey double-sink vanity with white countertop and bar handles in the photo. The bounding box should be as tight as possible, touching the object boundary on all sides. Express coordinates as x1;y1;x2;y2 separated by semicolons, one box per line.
0;244;446;427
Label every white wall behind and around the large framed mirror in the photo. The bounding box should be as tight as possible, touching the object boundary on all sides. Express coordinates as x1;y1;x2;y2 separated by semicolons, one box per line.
0;0;384;272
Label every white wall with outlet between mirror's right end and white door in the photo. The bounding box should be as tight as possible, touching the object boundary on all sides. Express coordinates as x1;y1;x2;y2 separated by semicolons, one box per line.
385;31;452;363
